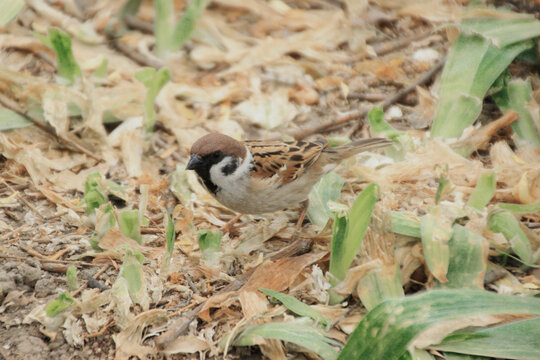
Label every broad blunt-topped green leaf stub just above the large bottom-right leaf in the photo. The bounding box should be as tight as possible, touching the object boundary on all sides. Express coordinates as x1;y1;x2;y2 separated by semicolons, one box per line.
441;224;489;290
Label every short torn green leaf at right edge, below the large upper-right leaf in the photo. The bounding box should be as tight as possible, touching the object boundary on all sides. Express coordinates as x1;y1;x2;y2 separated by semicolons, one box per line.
492;79;540;146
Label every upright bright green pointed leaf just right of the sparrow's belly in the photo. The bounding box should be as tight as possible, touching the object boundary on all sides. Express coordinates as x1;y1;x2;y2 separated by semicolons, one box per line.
330;183;379;285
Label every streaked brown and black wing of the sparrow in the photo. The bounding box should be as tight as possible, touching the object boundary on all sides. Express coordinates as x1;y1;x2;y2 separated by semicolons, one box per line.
245;140;328;184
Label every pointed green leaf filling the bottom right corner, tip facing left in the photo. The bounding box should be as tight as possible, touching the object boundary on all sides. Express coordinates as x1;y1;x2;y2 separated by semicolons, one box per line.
434;318;540;360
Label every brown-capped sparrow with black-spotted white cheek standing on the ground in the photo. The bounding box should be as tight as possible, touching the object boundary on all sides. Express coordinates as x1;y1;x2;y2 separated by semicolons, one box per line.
186;133;392;214
